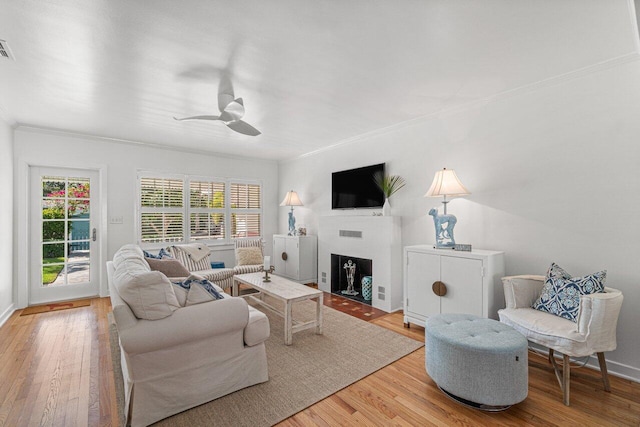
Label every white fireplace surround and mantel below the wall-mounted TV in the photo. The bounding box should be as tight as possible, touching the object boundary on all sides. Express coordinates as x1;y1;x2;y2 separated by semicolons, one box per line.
318;215;402;312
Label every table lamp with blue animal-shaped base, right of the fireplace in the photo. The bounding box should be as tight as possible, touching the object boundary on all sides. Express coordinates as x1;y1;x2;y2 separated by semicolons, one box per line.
424;168;471;249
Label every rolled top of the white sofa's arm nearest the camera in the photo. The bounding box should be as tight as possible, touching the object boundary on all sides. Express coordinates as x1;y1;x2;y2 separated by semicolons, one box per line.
118;297;249;356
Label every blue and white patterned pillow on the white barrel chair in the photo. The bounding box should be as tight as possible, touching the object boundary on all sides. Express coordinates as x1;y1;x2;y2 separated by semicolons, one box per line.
531;263;607;322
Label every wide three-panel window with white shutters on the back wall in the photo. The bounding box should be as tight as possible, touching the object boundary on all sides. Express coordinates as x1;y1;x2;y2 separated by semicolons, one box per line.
139;172;262;243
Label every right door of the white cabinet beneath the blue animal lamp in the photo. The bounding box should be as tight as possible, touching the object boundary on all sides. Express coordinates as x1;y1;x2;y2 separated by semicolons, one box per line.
440;256;483;317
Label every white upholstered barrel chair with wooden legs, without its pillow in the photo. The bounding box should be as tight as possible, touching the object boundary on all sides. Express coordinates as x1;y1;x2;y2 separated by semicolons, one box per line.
498;275;623;406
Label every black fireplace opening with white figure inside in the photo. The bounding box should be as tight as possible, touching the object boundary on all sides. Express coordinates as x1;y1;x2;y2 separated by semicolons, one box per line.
331;254;373;305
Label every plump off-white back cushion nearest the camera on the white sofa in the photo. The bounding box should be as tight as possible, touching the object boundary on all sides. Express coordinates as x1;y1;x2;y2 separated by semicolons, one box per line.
113;270;180;320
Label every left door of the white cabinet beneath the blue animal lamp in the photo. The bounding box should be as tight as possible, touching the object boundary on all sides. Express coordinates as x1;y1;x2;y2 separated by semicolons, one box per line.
405;251;440;317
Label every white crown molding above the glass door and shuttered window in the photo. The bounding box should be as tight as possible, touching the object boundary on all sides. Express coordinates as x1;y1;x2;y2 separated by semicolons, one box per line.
15;123;277;163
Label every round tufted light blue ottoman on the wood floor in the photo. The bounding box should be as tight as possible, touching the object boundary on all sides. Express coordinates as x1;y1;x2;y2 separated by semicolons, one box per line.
425;314;529;411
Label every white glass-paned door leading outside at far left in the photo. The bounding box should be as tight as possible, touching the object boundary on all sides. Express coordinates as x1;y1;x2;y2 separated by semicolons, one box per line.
29;167;100;305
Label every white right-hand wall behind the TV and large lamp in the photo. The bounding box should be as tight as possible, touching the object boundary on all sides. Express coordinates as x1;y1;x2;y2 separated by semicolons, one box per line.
278;61;640;380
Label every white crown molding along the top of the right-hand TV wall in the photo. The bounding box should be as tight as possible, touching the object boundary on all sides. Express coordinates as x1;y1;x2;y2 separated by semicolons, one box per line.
281;50;640;163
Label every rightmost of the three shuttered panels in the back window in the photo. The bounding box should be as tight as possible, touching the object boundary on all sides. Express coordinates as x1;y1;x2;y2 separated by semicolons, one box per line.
230;182;262;238
